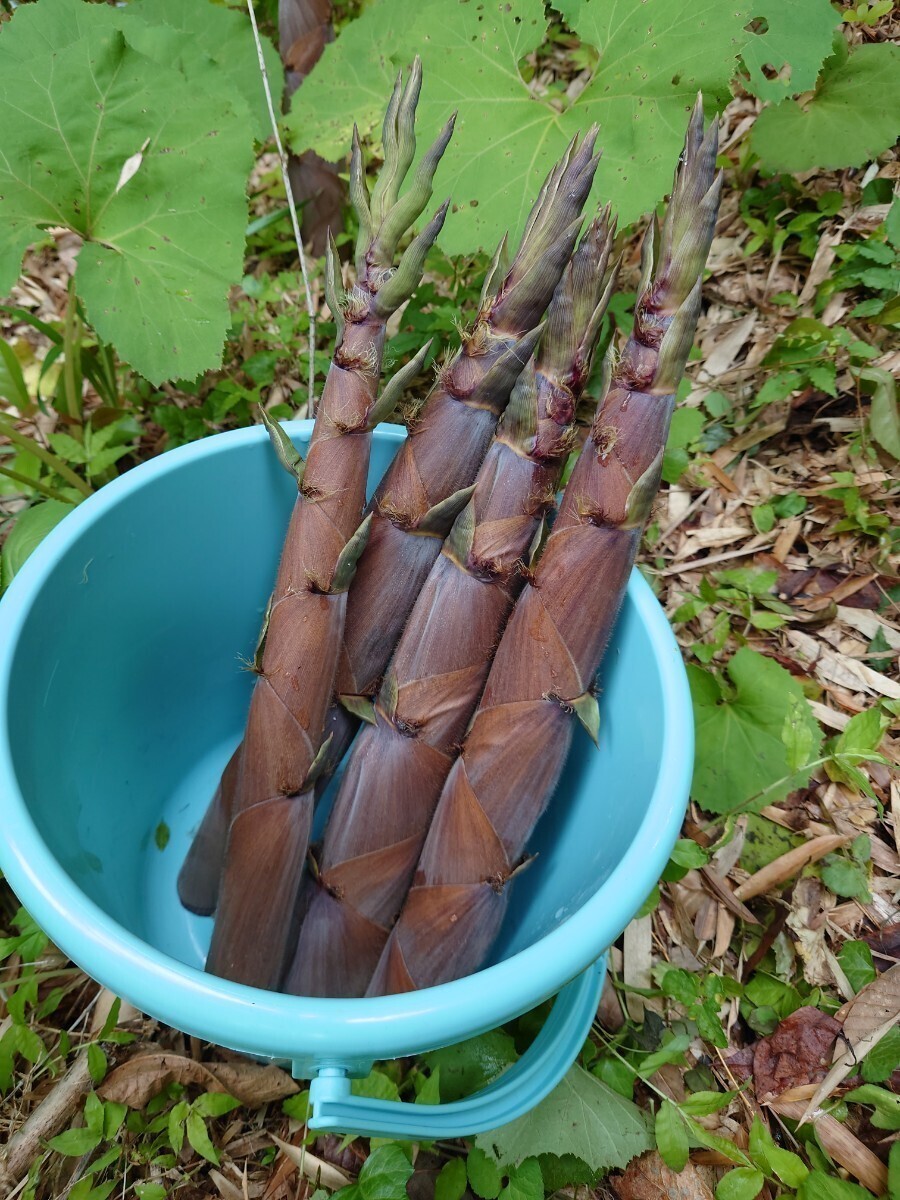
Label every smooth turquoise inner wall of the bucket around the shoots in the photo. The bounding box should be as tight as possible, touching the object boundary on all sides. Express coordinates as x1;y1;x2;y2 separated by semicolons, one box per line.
10;427;664;966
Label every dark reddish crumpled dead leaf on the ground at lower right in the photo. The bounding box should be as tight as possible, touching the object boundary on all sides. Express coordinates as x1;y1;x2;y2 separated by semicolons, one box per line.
728;1004;841;1100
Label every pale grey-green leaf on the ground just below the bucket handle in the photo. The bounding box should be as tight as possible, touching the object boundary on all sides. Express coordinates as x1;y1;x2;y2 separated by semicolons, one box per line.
475;1066;653;1171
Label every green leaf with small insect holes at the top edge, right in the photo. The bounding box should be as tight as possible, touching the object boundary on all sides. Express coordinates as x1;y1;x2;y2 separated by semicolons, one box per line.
740;0;841;101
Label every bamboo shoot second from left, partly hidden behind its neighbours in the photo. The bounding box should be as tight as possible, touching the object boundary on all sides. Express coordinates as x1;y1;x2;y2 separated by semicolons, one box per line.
309;130;607;806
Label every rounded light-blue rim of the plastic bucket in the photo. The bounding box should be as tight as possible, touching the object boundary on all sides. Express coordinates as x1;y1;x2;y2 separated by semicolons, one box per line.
0;420;694;1062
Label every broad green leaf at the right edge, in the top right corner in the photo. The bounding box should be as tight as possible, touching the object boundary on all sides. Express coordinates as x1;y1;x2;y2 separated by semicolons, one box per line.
750;40;900;170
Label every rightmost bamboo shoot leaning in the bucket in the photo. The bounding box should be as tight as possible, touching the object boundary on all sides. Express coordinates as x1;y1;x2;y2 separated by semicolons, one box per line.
368;102;721;995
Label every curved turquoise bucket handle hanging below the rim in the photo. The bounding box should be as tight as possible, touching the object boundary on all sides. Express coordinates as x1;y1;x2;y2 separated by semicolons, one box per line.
308;956;606;1141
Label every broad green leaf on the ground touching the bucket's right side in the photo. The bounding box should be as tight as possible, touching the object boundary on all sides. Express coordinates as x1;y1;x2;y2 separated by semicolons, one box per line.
688;647;822;812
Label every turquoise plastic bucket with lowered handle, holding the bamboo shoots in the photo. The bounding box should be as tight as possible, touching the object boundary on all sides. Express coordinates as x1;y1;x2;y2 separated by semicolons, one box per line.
0;422;692;1139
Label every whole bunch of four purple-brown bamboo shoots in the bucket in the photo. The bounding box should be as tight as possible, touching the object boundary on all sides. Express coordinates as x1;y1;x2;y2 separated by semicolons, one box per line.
179;61;721;996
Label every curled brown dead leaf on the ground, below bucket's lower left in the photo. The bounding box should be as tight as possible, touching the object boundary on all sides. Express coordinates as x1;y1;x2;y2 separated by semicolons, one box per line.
98;1051;299;1109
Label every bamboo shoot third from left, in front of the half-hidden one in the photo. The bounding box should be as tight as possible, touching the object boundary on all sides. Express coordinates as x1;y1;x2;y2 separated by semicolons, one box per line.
286;211;612;996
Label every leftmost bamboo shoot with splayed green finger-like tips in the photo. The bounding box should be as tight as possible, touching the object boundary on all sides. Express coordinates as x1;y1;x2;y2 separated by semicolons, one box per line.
190;60;452;988
